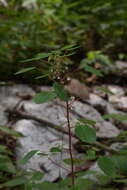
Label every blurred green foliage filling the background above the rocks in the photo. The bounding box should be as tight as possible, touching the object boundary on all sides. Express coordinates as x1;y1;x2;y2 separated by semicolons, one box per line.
0;0;127;82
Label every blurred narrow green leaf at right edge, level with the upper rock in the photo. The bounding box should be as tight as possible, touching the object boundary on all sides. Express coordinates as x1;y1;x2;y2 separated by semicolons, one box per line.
103;113;127;121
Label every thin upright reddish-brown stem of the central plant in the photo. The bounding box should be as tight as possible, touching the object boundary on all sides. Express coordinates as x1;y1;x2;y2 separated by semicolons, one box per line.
66;101;75;186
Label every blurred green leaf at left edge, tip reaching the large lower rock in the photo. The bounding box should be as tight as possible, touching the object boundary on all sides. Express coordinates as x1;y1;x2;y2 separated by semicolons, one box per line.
0;126;24;138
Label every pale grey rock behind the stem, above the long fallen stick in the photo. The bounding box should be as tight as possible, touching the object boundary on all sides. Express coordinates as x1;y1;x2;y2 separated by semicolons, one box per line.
24;97;119;138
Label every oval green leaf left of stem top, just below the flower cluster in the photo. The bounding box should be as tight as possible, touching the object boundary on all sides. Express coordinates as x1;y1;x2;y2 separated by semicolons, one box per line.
33;91;56;104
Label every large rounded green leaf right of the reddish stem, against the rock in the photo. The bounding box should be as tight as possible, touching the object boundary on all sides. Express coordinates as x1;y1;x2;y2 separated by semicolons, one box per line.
75;125;96;143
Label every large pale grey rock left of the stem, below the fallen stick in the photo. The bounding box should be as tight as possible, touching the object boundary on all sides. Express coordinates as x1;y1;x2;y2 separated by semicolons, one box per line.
15;120;77;181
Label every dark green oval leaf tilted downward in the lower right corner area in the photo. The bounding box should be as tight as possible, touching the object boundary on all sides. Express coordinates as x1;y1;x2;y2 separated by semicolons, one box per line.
98;156;116;177
